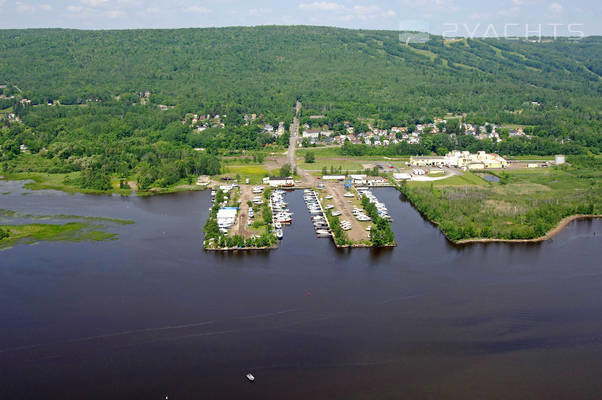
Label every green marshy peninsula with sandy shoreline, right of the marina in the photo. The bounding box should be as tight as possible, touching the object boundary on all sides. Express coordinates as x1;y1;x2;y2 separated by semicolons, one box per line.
402;159;602;241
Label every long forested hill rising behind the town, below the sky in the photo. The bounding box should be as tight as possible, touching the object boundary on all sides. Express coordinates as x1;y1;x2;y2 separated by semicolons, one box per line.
0;26;602;124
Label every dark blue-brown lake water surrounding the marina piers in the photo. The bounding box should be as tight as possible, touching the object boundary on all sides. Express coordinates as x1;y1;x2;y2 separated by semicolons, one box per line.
0;182;602;399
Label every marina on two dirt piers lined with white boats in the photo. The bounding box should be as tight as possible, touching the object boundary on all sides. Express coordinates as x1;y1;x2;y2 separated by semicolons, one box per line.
205;180;398;250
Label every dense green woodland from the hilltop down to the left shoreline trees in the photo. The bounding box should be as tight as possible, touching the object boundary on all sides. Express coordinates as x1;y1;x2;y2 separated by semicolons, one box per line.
0;26;602;190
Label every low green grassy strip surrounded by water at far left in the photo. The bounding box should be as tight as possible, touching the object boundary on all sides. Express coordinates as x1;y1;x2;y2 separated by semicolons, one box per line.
0;222;117;250
